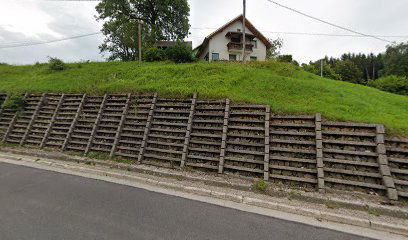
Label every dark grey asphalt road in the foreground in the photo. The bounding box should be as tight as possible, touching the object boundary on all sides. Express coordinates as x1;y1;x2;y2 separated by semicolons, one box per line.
0;163;367;240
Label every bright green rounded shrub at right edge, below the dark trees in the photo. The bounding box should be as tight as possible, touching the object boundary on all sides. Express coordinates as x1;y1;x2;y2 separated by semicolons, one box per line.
368;75;408;96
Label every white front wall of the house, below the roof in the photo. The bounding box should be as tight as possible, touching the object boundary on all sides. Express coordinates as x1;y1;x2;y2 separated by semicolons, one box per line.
207;21;266;61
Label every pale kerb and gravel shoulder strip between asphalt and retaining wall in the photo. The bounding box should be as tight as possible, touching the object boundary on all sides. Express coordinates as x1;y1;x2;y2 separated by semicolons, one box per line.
0;152;408;239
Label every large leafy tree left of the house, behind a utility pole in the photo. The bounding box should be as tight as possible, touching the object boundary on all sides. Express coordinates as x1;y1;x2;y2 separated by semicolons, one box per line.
96;0;190;61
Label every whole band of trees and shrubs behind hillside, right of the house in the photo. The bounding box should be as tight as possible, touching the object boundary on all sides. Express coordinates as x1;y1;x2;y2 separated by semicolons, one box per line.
302;42;408;95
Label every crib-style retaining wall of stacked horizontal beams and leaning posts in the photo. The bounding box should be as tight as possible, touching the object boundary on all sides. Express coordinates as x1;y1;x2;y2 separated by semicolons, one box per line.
0;94;408;200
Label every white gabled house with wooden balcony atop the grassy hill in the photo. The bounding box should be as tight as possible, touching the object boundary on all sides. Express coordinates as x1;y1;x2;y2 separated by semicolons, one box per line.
194;15;272;62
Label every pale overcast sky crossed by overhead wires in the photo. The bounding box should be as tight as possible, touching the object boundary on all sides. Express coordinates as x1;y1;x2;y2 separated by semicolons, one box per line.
0;0;408;64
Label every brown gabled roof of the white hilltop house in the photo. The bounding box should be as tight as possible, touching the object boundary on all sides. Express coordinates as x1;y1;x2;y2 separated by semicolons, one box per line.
194;14;272;56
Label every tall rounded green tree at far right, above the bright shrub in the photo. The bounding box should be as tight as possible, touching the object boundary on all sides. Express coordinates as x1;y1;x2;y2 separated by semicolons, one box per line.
381;42;408;77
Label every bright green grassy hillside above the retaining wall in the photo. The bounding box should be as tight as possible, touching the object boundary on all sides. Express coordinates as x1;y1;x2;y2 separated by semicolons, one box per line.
0;62;408;135
